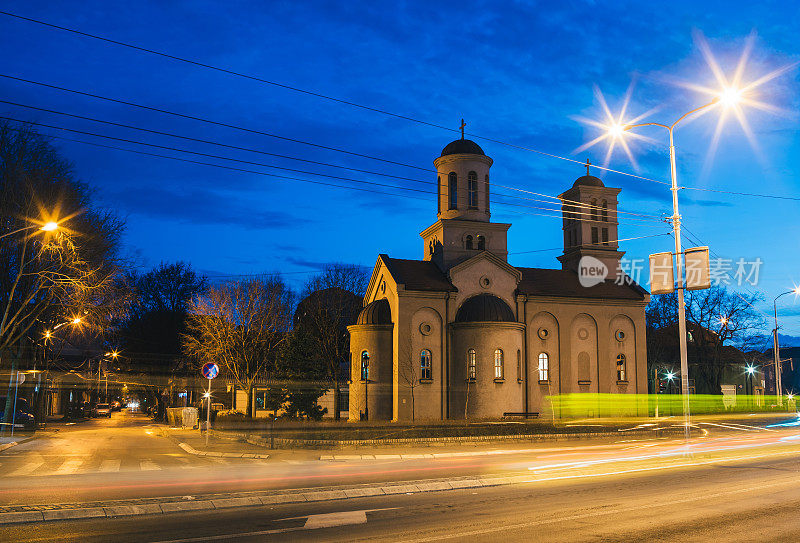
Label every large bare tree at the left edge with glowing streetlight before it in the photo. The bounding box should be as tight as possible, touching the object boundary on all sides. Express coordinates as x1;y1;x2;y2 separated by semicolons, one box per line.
0;122;122;430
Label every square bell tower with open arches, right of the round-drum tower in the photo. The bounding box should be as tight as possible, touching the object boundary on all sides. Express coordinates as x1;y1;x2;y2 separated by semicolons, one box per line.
558;160;625;278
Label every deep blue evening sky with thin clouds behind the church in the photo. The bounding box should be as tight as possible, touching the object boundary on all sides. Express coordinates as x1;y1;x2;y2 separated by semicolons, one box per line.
0;1;800;335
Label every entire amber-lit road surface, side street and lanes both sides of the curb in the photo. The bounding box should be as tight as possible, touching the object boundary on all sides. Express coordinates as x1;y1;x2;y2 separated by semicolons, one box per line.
0;415;800;542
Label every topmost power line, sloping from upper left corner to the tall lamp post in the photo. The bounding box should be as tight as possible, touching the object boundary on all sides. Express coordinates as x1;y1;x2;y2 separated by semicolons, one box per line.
0;11;670;186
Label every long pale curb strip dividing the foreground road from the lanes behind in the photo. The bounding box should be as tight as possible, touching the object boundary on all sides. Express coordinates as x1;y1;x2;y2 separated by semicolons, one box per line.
0;475;531;525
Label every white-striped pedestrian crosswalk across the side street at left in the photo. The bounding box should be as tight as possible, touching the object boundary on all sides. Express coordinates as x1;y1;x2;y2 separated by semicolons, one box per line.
0;455;264;478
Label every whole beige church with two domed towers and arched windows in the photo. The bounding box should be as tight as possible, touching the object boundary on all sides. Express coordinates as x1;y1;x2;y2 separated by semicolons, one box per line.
348;136;649;421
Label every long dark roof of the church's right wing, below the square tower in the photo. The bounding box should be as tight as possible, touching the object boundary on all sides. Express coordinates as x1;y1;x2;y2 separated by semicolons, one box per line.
517;268;647;301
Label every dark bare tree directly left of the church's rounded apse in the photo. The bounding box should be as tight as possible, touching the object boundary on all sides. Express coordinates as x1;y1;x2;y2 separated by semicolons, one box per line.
294;264;368;420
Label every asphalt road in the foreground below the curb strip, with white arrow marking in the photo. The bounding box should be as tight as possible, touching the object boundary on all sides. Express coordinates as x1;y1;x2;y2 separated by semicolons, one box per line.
0;444;800;543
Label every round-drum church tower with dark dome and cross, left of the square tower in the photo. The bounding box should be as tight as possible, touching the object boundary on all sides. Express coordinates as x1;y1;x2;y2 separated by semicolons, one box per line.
420;124;511;271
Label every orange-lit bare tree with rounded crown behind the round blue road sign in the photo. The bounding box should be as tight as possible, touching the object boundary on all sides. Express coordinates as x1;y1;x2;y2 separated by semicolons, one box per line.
184;276;294;416
